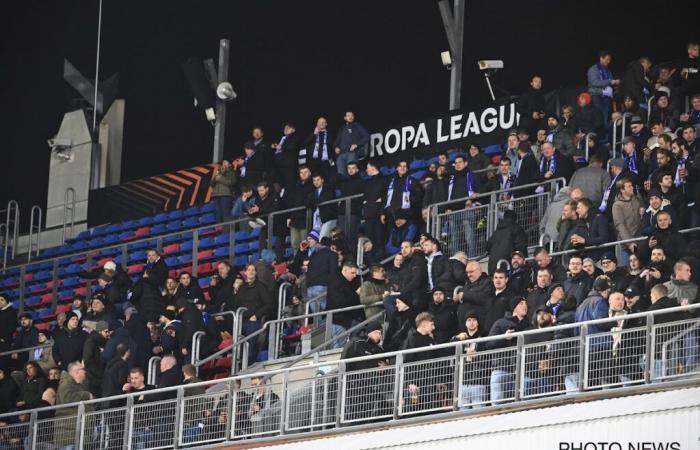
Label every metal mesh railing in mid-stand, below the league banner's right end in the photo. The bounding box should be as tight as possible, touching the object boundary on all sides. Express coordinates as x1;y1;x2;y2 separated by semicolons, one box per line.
428;178;566;258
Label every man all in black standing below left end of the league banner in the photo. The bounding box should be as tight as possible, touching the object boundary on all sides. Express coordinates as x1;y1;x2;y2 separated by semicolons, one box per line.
362;160;387;261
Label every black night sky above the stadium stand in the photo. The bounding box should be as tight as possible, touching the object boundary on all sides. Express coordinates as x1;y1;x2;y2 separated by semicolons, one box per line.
0;0;700;223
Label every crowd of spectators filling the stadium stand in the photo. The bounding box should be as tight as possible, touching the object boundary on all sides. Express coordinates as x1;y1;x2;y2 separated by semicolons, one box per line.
0;43;700;445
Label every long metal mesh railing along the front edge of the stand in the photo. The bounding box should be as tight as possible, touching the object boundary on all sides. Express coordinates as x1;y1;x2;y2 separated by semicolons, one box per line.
0;305;700;449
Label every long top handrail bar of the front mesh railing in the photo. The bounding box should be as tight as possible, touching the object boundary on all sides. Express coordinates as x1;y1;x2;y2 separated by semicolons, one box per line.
5;304;700;420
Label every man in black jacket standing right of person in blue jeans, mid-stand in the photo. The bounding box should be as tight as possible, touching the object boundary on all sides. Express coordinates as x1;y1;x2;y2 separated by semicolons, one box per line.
326;261;364;348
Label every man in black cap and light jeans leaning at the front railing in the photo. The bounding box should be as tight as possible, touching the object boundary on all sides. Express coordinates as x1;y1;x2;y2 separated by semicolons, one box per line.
486;297;531;405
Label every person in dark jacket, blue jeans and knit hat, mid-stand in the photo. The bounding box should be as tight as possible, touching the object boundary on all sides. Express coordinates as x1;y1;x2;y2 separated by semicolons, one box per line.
304;230;338;312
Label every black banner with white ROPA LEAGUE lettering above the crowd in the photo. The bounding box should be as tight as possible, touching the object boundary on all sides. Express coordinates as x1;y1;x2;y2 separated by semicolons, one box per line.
370;102;520;159
